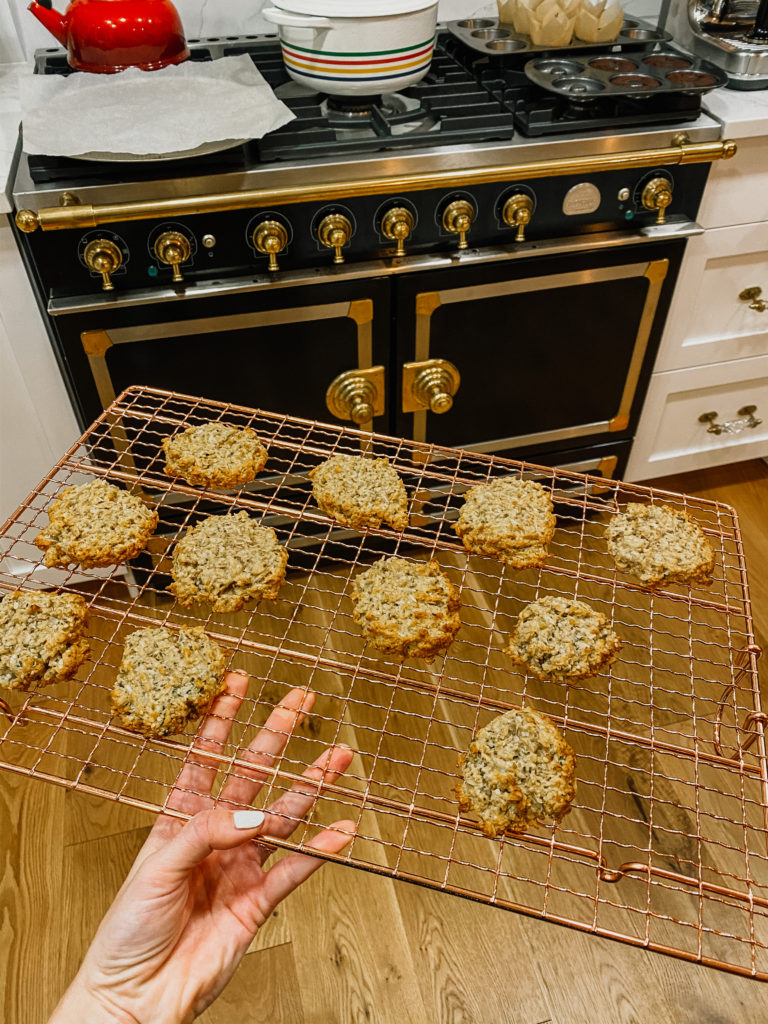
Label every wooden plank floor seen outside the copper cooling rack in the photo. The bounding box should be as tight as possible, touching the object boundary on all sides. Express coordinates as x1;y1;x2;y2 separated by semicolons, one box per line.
0;461;768;1024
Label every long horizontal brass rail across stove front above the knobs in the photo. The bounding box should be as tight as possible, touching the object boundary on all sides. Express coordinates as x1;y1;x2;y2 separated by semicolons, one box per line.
16;141;736;231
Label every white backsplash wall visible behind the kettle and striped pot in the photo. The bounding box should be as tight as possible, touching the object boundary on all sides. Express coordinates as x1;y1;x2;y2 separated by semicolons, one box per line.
7;0;663;63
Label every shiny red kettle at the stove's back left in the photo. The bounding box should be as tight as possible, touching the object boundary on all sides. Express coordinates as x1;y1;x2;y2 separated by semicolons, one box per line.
29;0;189;74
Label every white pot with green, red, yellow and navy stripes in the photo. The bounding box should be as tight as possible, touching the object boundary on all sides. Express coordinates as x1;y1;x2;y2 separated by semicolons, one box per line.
261;0;437;96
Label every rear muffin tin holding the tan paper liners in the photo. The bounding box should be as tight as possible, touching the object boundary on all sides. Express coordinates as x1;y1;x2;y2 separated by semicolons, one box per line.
447;17;672;56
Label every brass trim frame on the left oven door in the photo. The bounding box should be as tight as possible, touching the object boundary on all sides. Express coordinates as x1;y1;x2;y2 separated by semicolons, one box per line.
80;299;374;419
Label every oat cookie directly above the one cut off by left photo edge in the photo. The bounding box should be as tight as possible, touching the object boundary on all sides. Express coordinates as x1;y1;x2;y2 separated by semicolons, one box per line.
35;479;158;568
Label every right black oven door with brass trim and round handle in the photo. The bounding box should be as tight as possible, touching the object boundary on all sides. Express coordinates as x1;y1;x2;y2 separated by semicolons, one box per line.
396;237;685;456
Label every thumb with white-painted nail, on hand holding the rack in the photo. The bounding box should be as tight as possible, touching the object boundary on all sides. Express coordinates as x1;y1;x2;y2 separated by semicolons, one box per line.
155;808;264;876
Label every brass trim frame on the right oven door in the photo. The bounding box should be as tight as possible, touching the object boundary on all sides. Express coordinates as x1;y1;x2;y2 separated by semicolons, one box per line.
413;259;670;452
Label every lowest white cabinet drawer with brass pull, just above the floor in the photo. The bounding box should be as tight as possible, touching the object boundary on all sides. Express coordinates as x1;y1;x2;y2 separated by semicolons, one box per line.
627;355;768;480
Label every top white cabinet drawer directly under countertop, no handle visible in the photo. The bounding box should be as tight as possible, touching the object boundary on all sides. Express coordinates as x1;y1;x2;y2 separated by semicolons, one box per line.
696;136;768;227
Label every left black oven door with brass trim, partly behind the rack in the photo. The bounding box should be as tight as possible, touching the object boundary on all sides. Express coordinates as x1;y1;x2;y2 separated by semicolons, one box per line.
53;279;390;431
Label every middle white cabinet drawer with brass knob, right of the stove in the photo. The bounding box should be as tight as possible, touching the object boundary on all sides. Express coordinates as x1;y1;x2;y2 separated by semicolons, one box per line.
655;223;768;372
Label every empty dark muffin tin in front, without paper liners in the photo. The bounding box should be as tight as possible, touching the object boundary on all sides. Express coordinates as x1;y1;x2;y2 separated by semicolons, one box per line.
524;47;727;101
